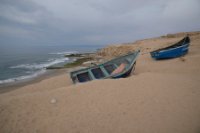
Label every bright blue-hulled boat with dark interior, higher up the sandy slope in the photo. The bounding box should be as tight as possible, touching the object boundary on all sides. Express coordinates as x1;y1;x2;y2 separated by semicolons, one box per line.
150;36;190;60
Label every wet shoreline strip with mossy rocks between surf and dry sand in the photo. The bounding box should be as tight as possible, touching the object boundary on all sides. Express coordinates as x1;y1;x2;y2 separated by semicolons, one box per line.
0;52;96;94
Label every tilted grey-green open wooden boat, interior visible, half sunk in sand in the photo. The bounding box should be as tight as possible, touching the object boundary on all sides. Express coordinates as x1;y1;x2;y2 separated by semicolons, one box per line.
70;50;140;83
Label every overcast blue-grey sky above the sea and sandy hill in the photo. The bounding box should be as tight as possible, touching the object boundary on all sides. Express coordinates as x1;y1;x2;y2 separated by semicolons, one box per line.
0;0;200;45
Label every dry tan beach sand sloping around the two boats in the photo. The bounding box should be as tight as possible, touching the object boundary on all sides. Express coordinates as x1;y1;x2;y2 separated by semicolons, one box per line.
0;31;200;133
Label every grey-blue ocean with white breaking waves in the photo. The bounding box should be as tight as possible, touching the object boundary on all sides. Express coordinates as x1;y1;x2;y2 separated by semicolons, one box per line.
0;45;103;85
